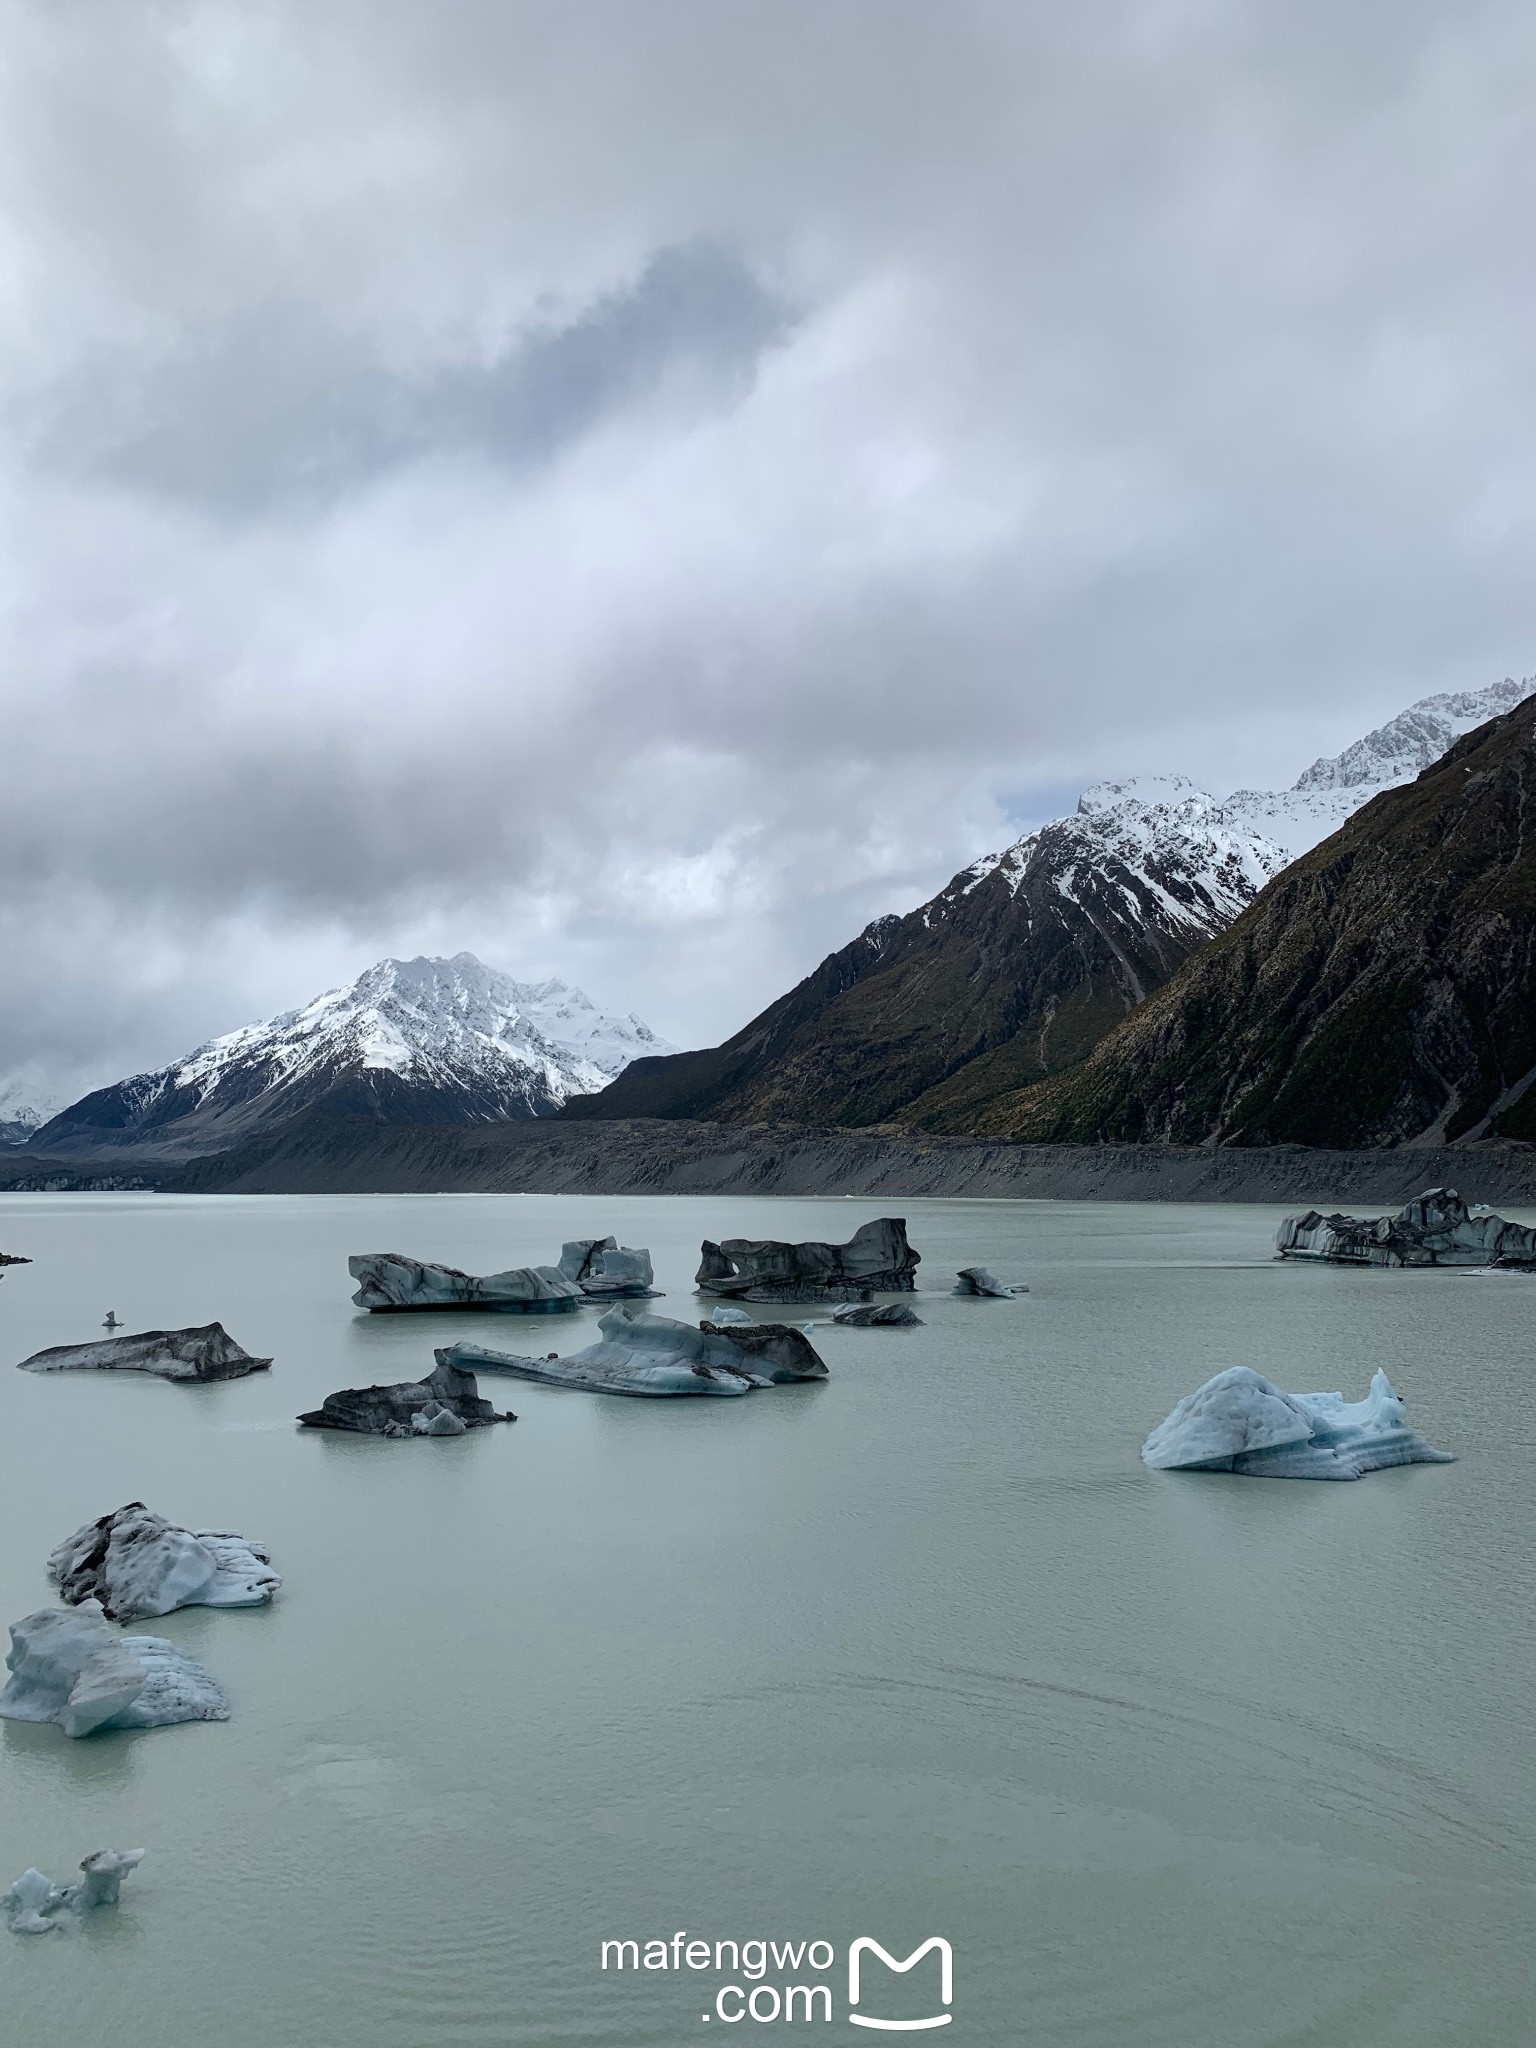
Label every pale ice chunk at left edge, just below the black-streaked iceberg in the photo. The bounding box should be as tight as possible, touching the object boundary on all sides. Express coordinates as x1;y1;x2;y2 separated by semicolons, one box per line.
0;1599;229;1735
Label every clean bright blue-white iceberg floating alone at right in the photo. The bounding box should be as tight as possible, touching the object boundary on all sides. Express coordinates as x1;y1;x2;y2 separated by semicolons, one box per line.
1141;1366;1456;1479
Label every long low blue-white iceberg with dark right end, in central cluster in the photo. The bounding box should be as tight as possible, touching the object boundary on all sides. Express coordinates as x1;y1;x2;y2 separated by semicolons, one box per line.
436;1309;827;1397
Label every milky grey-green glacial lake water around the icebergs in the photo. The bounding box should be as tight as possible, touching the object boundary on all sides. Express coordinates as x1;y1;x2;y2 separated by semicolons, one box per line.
0;1190;1536;2048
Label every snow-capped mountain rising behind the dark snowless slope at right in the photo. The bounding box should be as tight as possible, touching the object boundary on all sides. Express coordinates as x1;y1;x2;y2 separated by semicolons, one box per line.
565;678;1536;1130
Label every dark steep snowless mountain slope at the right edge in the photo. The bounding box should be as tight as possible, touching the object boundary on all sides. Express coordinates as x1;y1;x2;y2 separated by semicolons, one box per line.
1003;700;1536;1145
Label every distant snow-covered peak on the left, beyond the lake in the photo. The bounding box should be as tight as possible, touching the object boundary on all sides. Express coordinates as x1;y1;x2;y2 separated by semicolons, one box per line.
29;952;670;1157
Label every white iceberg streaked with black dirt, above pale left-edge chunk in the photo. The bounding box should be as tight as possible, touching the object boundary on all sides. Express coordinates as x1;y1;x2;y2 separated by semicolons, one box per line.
47;1501;283;1622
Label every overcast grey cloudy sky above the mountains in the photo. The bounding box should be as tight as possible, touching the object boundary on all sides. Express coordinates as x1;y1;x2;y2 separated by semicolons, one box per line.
0;0;1536;1094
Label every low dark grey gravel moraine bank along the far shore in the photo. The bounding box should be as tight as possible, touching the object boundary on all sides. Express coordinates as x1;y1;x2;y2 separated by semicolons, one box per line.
0;1118;1536;1208
